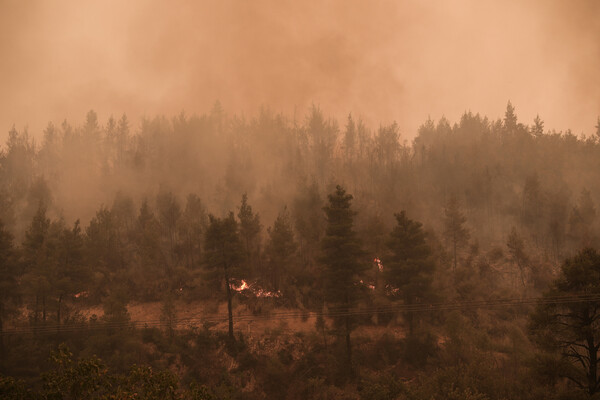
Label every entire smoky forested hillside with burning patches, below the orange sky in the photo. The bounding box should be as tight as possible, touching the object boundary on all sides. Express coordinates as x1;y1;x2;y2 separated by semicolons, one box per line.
0;102;600;399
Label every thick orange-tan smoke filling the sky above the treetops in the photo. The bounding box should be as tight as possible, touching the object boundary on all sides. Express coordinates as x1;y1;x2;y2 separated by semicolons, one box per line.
0;0;600;139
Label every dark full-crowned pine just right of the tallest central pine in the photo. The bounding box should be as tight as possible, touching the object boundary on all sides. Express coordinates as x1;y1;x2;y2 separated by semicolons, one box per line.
383;211;435;336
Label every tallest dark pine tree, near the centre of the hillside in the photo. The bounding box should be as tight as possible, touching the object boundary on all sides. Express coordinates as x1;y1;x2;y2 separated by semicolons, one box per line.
321;185;367;372
